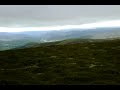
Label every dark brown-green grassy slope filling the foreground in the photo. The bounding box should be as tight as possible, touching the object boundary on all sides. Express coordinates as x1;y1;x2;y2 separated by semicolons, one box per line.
0;40;120;85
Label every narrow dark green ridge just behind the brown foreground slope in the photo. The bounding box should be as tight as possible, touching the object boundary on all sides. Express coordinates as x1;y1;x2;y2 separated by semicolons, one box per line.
15;38;108;49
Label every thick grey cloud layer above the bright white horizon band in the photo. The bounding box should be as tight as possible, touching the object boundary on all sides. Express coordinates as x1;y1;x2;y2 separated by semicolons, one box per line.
0;5;120;27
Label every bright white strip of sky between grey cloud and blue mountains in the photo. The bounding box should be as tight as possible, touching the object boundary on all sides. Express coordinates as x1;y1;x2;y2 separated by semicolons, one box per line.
0;20;120;32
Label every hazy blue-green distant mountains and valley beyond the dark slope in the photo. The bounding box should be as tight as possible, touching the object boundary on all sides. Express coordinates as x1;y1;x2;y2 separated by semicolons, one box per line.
0;27;120;51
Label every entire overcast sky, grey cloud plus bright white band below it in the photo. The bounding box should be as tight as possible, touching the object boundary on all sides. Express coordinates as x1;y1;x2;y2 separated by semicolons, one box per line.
0;5;120;32
